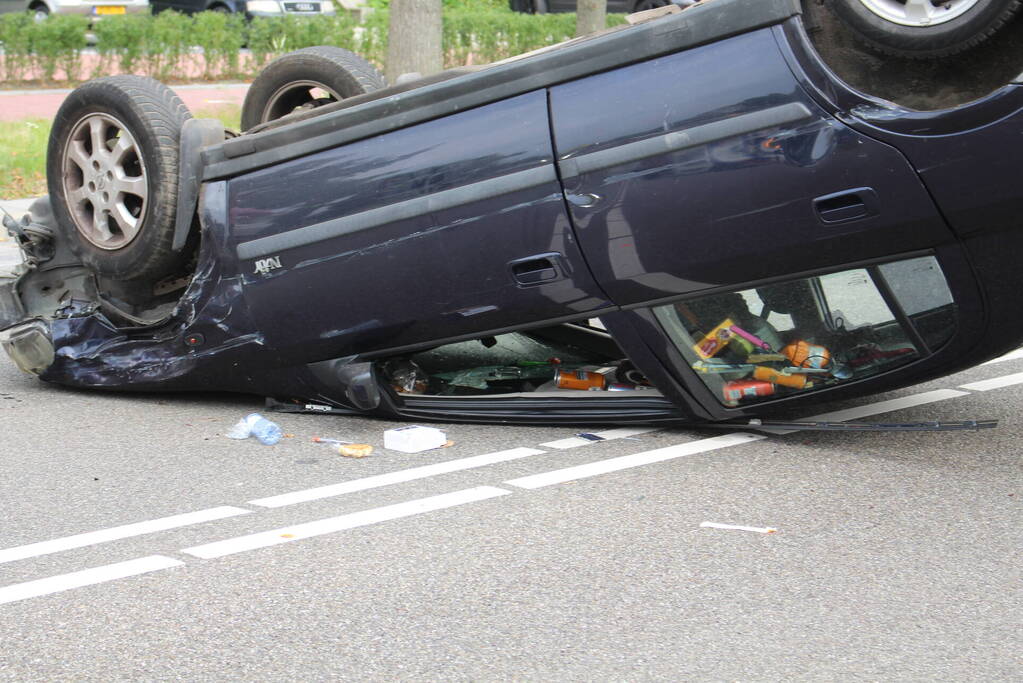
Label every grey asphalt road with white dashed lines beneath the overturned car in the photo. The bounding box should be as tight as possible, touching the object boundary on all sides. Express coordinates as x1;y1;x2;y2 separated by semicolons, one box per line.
0;341;1023;681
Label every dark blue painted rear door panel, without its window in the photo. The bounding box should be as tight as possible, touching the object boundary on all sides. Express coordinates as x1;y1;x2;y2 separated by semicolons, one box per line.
550;30;953;305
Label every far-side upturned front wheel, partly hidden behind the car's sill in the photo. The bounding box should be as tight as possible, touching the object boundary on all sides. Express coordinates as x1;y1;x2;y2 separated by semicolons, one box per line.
241;46;387;131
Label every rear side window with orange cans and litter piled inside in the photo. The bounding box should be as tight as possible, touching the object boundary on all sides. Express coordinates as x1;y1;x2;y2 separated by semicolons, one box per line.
654;257;955;406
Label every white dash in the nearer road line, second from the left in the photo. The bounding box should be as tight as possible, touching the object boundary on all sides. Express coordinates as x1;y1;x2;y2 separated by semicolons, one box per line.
181;486;512;559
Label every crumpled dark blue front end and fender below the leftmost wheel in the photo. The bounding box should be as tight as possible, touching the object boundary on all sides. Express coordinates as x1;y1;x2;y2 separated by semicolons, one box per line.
0;193;381;417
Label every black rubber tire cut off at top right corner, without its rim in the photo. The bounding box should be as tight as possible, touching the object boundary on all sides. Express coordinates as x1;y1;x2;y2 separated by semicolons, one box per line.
828;0;1019;57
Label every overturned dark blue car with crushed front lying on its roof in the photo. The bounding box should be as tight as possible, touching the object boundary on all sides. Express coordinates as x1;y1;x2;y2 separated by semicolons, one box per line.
0;0;1023;423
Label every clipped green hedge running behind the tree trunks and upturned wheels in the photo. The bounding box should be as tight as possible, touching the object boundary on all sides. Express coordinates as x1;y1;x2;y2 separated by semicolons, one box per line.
0;5;624;84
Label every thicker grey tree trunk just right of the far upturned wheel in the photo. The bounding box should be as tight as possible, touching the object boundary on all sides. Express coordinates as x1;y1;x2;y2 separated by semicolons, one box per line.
385;0;444;84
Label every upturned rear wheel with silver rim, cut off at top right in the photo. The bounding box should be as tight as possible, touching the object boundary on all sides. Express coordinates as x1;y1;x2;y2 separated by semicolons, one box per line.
828;0;1023;58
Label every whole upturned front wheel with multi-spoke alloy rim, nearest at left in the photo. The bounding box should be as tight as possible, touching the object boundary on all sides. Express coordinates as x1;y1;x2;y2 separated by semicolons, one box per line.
46;76;191;282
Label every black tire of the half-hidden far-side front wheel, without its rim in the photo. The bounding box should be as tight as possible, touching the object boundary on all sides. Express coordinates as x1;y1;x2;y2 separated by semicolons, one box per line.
241;46;386;131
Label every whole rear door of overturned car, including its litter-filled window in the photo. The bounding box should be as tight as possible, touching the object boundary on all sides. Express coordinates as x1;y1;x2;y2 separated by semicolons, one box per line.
550;29;957;417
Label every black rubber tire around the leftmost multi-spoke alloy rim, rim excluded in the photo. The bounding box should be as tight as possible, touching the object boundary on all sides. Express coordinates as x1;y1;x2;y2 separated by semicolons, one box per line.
46;77;188;282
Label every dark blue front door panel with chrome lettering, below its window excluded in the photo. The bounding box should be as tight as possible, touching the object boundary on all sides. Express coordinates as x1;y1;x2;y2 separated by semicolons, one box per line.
228;91;610;361
